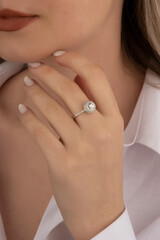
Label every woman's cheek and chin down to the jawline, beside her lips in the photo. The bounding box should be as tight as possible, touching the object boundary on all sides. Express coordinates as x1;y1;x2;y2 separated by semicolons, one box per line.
0;0;113;62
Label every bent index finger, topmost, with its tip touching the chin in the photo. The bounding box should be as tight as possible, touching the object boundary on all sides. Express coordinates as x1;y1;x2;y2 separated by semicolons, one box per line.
54;51;119;116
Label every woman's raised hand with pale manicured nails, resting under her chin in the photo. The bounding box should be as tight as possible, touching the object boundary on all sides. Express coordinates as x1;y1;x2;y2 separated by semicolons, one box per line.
17;51;125;240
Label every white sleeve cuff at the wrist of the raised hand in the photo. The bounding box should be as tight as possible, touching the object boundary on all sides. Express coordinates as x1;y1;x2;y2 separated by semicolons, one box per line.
91;208;136;240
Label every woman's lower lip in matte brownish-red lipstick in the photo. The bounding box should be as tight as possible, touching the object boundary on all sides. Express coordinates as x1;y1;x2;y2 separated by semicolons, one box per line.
0;16;38;32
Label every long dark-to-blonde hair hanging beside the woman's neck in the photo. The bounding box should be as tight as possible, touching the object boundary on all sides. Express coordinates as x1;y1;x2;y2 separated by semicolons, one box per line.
0;0;160;75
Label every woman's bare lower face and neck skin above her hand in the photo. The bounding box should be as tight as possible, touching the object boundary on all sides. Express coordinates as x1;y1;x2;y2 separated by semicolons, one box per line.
0;0;144;126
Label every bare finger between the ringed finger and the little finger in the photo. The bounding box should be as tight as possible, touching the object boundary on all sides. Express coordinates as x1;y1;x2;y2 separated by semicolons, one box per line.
24;78;80;146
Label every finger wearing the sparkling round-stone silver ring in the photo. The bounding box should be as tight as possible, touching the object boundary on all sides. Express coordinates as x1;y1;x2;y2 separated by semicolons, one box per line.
29;64;101;128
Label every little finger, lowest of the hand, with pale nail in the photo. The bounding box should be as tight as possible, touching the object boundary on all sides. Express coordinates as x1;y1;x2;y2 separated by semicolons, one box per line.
18;104;65;169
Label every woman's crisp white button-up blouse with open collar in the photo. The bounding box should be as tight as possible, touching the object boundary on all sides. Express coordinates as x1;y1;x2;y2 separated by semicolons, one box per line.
0;62;160;240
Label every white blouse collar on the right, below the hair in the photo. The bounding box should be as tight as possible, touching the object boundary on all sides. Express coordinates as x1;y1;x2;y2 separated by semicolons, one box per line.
124;68;160;154
